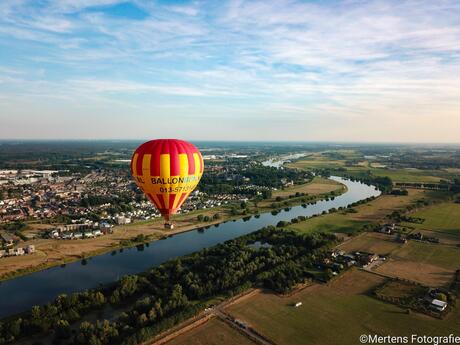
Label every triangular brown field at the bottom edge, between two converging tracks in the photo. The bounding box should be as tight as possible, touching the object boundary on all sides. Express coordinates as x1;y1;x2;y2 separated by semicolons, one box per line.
166;318;255;345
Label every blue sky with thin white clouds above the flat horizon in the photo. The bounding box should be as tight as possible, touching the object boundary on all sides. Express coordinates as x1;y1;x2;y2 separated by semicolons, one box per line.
0;0;460;142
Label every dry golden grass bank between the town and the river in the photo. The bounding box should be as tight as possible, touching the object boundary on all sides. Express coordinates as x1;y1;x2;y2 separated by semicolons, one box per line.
0;178;347;281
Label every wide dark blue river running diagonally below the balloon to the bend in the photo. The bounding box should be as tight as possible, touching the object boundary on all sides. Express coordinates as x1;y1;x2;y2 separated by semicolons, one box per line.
0;177;380;318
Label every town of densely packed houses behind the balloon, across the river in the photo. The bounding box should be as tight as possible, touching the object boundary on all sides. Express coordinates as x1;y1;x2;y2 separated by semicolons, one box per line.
0;154;284;257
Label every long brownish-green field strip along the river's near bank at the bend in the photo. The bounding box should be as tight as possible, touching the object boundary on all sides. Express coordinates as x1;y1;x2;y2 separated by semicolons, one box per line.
290;190;428;233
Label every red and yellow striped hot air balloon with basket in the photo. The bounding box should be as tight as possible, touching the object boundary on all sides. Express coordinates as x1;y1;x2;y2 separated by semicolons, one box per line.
131;139;204;229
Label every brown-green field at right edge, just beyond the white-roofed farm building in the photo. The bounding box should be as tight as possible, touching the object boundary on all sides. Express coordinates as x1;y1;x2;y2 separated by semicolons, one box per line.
377;241;460;287
